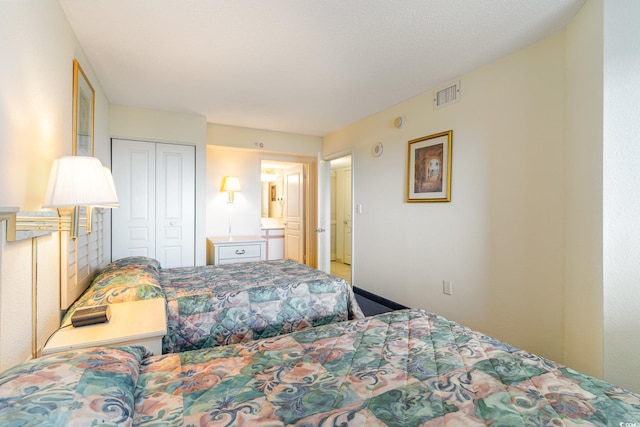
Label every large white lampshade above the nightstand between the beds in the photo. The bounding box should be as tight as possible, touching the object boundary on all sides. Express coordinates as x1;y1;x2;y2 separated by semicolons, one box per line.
42;156;120;208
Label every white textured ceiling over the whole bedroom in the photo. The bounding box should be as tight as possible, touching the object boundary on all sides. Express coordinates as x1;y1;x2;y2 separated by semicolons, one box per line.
59;0;584;136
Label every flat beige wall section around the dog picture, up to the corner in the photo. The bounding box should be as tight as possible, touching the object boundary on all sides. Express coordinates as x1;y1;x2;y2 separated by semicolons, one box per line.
323;33;566;366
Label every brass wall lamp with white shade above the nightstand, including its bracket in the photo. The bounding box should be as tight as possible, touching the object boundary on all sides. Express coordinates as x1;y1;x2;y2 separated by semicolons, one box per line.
7;156;120;241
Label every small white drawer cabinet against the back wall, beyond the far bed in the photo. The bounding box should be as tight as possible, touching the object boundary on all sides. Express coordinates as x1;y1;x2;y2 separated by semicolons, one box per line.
207;236;267;265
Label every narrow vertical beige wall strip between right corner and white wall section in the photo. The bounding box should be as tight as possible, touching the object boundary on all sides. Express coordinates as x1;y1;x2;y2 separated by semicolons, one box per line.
564;1;604;377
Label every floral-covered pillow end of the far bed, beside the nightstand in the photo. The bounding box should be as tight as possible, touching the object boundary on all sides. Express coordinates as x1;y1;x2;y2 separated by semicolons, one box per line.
62;257;164;324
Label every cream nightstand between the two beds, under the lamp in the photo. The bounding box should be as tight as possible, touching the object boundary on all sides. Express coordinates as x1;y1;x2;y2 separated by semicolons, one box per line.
42;298;167;355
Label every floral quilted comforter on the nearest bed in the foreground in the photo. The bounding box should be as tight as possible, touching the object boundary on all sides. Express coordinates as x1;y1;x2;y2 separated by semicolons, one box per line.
0;310;640;427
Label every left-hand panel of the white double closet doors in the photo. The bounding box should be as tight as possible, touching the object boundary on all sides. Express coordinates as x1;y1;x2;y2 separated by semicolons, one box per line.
111;139;156;259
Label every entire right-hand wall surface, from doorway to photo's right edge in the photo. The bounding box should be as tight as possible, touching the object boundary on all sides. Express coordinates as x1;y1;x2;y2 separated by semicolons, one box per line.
323;0;640;391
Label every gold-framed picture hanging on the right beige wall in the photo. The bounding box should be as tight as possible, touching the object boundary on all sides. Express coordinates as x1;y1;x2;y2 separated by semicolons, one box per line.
406;131;453;202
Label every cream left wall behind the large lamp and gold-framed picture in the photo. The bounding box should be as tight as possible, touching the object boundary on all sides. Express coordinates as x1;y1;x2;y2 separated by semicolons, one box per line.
0;0;110;370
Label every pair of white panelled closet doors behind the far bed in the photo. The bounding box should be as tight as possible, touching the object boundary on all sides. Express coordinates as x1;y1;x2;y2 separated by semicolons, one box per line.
111;139;195;268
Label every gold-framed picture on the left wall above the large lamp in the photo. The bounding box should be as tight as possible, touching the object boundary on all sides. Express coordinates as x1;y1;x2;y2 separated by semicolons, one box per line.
72;59;95;157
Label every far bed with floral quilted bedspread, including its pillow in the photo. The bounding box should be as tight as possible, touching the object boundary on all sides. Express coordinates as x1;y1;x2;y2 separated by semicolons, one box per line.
63;257;364;353
